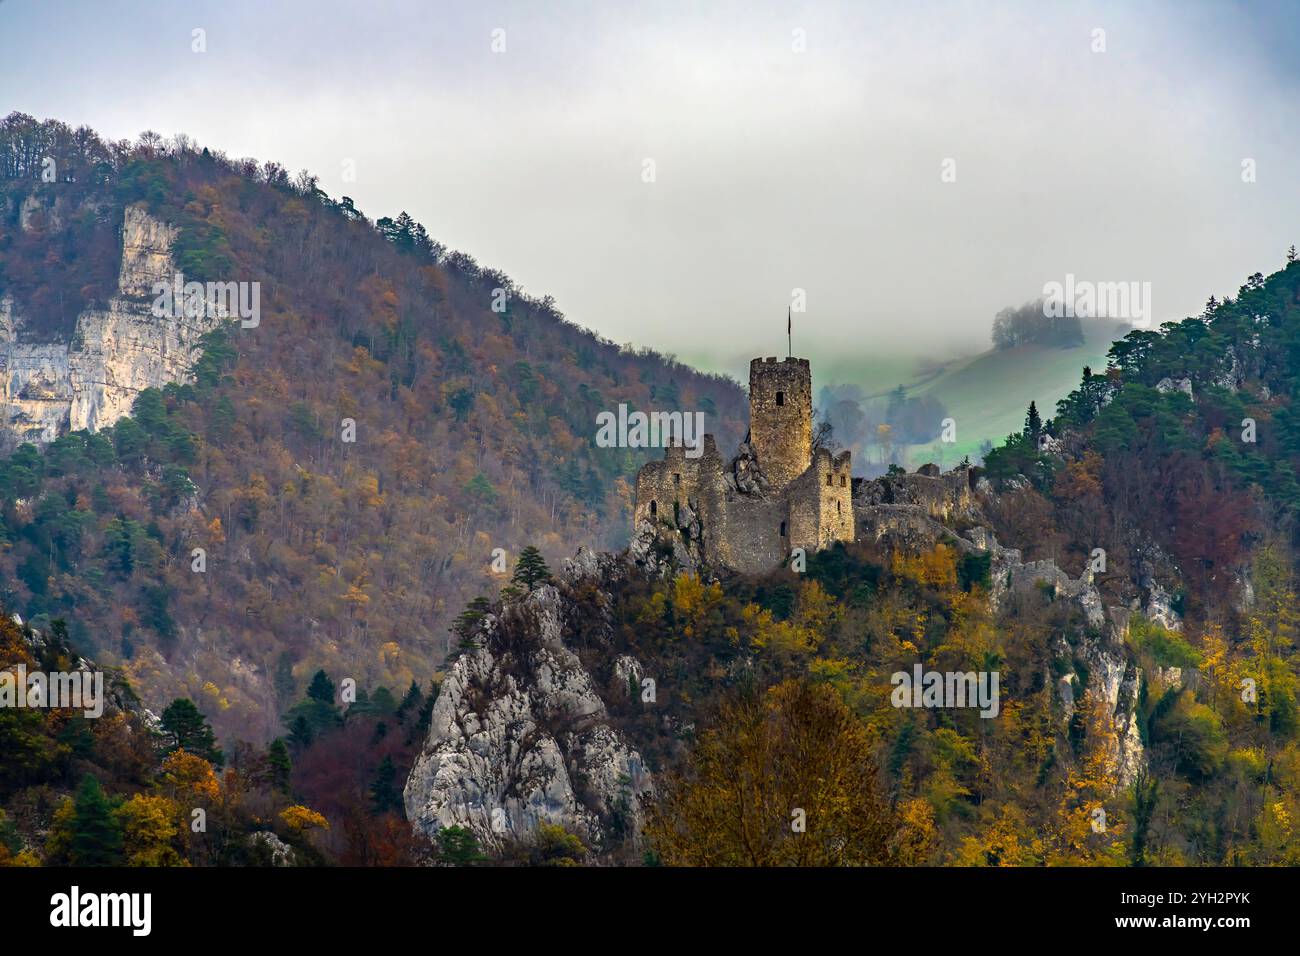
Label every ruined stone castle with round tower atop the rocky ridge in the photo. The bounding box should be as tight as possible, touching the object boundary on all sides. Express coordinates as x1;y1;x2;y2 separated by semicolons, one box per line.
633;358;854;574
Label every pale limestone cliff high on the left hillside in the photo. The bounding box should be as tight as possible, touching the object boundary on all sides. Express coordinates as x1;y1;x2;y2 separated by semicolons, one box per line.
0;204;220;445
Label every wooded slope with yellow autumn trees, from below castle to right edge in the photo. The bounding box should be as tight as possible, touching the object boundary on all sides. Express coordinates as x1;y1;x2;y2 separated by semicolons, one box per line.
620;250;1300;866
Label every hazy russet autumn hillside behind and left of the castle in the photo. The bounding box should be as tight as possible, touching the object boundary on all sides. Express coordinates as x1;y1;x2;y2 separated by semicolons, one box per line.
0;113;745;739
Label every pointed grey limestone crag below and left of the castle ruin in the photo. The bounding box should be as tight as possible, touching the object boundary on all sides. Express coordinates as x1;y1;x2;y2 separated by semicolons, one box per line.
404;585;653;847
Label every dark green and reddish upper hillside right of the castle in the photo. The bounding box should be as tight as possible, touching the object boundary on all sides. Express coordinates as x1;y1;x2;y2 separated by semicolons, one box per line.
985;250;1300;606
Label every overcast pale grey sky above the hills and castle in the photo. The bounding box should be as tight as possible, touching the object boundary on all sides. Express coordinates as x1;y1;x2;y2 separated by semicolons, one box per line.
0;0;1300;377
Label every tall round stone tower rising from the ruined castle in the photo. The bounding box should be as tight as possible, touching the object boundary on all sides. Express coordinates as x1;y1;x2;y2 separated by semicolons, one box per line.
749;358;813;492
